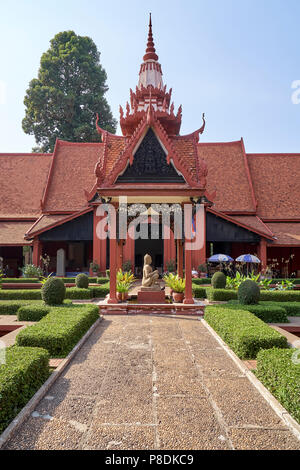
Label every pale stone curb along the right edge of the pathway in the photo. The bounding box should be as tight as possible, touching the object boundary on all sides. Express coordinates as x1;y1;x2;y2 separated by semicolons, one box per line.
200;319;300;441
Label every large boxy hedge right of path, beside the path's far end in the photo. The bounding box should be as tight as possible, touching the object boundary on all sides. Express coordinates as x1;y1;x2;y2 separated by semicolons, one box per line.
204;306;288;359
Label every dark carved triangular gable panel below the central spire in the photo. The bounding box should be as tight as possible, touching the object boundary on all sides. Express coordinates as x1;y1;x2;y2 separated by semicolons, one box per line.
117;128;185;183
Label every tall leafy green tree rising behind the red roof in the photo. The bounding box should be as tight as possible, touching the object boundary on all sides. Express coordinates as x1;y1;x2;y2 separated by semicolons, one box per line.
22;31;117;152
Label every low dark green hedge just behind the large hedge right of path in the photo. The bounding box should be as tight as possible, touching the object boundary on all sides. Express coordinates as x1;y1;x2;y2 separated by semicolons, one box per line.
226;301;289;323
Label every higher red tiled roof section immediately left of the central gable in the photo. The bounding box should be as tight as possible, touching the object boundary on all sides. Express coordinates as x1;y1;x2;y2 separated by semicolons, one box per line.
43;140;103;212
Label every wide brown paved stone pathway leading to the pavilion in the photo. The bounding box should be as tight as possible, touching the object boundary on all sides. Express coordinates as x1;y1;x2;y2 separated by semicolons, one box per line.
6;316;300;450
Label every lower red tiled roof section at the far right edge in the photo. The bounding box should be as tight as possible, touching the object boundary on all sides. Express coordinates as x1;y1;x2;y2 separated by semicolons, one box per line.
247;154;300;219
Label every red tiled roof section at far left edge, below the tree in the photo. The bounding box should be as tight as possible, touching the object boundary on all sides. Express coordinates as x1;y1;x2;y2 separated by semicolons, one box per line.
0;154;52;218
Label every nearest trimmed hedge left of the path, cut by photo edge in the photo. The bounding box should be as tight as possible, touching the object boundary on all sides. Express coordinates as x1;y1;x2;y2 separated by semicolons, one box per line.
0;346;49;433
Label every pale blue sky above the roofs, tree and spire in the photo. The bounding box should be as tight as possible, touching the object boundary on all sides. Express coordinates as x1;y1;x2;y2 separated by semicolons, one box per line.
0;0;300;152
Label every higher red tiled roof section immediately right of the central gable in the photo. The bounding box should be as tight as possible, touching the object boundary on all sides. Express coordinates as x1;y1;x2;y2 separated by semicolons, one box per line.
198;140;256;212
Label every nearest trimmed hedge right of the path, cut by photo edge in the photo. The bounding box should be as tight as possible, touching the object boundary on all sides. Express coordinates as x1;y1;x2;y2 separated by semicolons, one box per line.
256;349;300;424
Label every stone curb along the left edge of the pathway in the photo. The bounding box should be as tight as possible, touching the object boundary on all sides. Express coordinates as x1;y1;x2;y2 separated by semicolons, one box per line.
0;317;103;449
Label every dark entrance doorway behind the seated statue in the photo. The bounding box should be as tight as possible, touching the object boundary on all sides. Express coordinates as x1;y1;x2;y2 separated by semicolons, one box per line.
135;224;164;276
